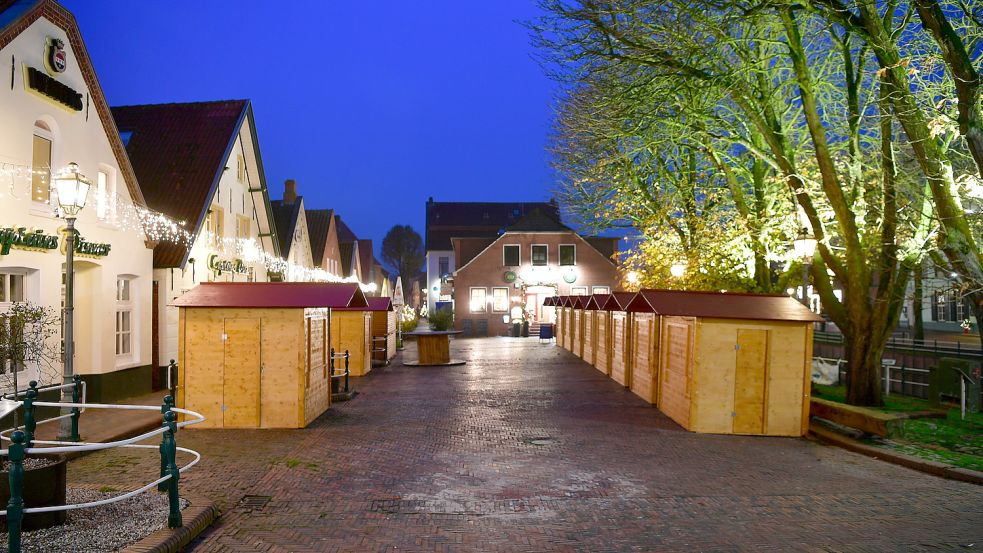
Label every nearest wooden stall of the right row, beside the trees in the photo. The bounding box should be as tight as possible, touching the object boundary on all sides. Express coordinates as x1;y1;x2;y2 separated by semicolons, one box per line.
628;290;822;436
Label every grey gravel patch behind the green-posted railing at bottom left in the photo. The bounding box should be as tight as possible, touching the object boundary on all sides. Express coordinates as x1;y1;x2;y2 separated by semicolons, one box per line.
0;488;188;553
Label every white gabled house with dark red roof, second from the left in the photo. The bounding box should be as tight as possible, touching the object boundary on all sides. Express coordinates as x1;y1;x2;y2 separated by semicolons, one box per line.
112;100;286;374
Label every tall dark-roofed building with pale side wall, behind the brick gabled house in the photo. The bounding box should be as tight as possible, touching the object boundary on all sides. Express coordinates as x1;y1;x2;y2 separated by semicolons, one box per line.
424;198;560;311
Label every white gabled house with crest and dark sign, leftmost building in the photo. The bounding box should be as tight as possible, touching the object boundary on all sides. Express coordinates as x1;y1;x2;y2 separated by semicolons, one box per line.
0;0;153;401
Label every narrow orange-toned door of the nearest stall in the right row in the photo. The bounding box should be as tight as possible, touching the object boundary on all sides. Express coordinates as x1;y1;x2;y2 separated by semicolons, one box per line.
734;329;768;434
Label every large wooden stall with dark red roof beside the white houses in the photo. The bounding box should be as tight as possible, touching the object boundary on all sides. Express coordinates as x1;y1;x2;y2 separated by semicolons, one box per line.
174;282;368;428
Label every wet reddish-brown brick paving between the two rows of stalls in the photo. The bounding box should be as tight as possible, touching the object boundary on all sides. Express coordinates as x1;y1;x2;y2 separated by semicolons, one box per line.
69;338;983;552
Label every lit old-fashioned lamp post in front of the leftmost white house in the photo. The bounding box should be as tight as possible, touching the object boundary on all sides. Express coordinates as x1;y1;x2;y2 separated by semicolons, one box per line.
55;162;91;442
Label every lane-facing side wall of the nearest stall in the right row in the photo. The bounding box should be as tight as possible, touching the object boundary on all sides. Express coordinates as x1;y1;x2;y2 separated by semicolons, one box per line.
659;317;696;430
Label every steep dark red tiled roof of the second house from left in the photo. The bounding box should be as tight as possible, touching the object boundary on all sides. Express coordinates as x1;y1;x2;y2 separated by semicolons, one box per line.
112;100;279;267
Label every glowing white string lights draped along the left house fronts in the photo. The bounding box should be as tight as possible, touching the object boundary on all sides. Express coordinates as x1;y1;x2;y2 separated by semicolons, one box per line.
0;163;377;292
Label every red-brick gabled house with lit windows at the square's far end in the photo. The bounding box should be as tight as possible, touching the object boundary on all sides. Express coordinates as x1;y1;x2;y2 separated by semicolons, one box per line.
451;209;618;336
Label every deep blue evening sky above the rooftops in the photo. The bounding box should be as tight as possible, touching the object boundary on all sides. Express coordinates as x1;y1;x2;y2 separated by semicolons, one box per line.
63;0;556;251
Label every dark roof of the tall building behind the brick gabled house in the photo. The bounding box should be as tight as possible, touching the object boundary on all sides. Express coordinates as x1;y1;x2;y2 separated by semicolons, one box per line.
425;198;560;251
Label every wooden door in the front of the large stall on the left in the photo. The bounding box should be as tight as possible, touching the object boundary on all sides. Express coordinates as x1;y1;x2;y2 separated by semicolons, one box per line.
222;319;261;428
